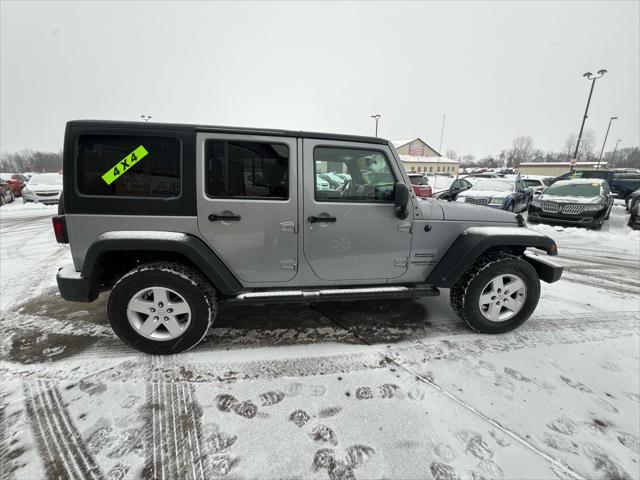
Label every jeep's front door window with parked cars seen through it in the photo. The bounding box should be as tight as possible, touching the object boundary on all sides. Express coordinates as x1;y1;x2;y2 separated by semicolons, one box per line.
313;147;395;202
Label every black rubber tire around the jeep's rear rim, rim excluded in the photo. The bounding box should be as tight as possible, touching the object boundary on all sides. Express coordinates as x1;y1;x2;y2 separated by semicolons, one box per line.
107;262;217;355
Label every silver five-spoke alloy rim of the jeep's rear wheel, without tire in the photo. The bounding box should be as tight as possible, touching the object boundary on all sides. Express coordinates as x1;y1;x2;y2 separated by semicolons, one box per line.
127;287;191;341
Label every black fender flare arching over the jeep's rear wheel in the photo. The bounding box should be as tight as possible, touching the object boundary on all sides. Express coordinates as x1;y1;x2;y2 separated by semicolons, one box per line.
81;231;243;296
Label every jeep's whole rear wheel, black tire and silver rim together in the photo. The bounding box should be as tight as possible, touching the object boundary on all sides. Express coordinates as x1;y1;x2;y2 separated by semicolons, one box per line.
107;262;217;355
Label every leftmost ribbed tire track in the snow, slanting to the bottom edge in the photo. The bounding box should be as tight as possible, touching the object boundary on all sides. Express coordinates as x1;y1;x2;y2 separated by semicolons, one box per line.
24;380;104;480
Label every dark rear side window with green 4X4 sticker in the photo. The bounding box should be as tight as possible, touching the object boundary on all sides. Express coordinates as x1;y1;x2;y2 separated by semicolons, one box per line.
76;135;181;198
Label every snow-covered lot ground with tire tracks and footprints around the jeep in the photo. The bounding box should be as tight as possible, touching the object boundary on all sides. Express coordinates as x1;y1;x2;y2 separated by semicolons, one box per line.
0;204;640;480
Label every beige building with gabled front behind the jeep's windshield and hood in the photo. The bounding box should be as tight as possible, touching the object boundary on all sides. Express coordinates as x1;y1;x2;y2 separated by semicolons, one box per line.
391;138;460;177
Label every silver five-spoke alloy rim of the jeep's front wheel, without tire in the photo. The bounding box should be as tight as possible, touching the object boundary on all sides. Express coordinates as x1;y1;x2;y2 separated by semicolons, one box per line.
479;274;527;322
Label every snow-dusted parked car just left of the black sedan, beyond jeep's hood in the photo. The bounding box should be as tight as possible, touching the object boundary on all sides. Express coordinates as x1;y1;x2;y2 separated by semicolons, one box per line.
456;178;533;212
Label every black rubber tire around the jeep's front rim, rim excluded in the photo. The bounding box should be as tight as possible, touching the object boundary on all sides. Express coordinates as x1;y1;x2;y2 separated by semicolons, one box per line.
449;253;540;334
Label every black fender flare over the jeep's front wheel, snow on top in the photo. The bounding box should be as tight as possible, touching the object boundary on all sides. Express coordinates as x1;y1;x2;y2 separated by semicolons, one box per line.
427;227;562;288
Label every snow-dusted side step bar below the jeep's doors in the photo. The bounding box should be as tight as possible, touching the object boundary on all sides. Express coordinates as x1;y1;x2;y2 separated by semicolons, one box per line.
226;285;440;305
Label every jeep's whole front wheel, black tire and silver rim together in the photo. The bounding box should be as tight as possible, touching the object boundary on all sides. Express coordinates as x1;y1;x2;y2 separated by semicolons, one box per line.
450;253;540;333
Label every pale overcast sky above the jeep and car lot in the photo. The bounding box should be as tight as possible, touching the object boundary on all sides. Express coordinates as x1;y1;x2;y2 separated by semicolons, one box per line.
0;1;640;157
